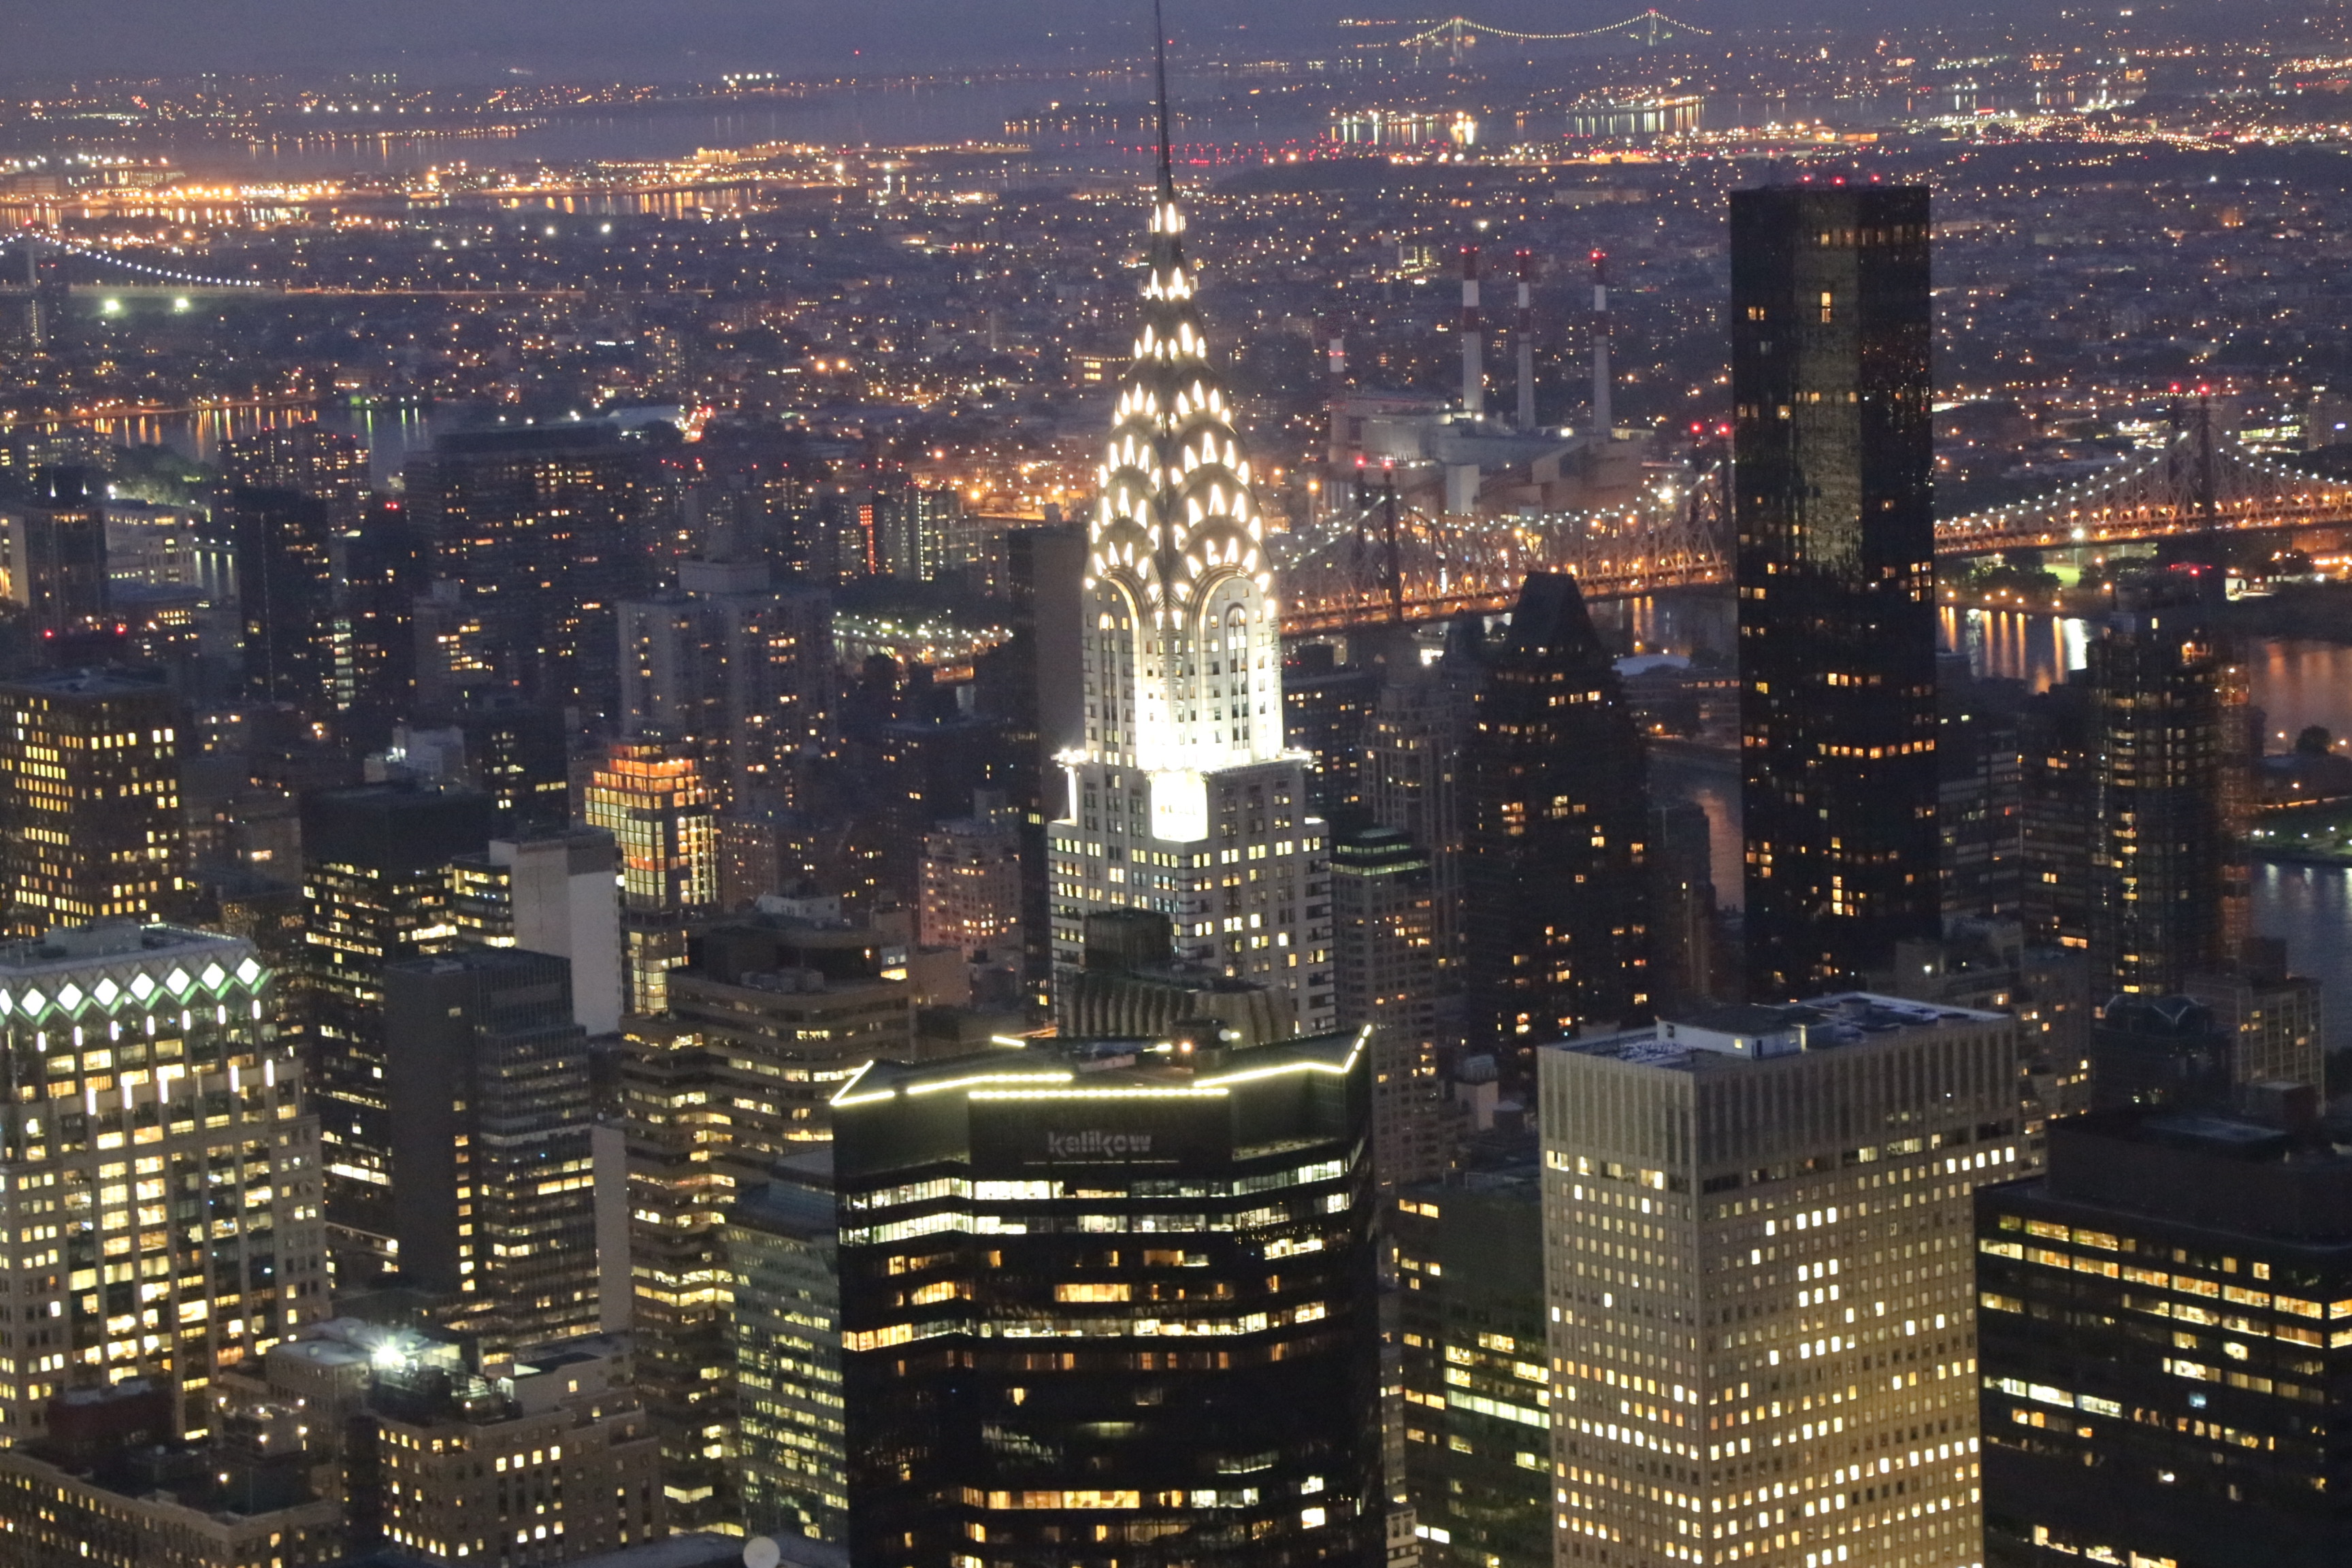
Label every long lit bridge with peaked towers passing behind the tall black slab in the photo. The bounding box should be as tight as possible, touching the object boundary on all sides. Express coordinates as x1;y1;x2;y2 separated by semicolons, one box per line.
1275;421;2352;635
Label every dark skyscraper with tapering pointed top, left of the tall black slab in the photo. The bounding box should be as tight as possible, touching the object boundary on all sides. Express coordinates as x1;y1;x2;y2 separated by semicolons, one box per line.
1463;574;1654;1067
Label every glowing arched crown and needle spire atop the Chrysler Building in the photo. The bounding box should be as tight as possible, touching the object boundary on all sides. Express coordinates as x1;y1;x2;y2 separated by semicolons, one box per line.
1087;0;1282;771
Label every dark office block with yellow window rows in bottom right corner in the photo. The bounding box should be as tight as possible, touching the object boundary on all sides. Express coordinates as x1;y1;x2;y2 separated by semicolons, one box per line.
1974;1091;2352;1568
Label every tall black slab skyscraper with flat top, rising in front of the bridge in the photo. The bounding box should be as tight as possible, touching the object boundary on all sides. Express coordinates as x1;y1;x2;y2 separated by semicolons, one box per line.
1731;183;1938;1002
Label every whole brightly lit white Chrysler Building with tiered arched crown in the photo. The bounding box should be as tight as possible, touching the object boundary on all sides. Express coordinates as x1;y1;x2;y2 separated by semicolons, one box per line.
1049;137;1334;1034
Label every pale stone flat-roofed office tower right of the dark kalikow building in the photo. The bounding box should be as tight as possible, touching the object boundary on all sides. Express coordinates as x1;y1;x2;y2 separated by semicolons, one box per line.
1529;994;2021;1568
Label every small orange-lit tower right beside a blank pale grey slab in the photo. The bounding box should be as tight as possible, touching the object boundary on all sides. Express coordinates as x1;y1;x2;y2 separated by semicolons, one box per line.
583;740;720;1013
